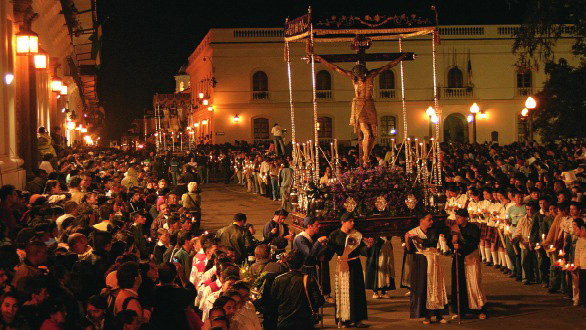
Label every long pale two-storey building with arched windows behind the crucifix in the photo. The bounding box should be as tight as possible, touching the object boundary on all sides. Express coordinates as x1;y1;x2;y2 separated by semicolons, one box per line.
187;25;577;143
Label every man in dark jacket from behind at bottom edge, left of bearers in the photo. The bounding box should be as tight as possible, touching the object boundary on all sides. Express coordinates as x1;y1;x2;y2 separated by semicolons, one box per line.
270;250;324;330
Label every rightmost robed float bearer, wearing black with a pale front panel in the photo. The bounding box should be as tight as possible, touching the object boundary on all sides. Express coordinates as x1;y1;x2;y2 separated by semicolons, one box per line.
451;209;486;320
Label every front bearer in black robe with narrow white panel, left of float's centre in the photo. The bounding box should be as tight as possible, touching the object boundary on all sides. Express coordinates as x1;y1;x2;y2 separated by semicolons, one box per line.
328;213;373;328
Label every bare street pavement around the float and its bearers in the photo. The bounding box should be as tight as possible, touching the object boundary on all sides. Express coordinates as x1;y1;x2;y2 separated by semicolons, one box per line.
202;183;586;329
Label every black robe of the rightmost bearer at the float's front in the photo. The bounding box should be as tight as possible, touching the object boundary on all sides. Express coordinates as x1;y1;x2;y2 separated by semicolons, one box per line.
447;223;480;315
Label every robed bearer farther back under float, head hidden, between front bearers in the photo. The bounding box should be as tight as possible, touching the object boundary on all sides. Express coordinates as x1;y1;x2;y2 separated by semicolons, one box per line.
365;236;396;299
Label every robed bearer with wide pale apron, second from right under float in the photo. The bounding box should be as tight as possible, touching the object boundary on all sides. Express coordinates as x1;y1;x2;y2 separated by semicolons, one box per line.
405;214;448;324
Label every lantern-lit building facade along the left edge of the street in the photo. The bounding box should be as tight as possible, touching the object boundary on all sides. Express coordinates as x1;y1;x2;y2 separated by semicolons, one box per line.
0;0;104;188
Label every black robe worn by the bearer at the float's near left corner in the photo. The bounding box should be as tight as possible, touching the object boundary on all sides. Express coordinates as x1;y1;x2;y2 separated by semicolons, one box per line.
328;229;368;323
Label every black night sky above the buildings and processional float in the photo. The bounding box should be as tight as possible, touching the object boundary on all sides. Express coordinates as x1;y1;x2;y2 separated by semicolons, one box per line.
98;0;524;139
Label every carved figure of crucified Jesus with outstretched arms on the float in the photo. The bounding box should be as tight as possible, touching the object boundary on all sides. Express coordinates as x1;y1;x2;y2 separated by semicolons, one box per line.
314;54;407;166
